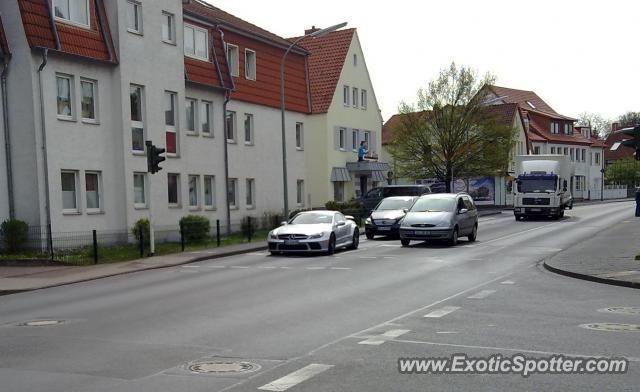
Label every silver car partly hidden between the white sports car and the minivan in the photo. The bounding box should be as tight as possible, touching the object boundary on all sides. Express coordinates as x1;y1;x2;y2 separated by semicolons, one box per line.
364;196;418;239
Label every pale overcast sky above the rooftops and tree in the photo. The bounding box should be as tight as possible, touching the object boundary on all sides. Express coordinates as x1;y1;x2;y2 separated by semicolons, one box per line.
208;0;640;121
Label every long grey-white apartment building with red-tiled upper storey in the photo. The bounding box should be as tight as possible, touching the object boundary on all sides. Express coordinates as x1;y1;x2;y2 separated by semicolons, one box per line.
0;0;310;231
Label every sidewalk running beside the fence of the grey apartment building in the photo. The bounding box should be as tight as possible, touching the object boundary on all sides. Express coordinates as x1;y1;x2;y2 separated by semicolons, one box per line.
0;241;267;295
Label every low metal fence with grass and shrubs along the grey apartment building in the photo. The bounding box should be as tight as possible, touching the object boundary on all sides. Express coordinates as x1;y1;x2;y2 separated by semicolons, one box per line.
0;215;283;265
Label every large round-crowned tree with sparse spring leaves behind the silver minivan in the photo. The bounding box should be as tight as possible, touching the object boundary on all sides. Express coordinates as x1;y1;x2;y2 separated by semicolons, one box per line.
389;63;515;192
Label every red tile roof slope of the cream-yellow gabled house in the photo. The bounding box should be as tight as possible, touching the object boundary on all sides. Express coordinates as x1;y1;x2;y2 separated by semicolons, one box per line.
290;29;356;113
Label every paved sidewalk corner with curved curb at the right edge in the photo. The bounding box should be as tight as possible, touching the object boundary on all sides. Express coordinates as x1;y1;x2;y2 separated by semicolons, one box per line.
544;217;640;288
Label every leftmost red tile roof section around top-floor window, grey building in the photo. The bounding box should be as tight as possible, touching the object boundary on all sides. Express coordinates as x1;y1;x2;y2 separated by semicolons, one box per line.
18;0;117;63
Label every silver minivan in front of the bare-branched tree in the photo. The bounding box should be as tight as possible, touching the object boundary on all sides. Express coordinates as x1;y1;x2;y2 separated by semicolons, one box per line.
400;193;478;246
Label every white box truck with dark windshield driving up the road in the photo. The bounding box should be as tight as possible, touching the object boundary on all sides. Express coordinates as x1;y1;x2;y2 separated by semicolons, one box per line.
513;155;574;220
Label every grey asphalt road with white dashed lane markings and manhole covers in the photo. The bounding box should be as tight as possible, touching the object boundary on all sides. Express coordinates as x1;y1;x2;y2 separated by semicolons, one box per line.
0;202;640;392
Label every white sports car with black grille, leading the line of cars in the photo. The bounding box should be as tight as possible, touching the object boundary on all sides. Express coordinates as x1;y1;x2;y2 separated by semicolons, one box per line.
267;210;360;254
